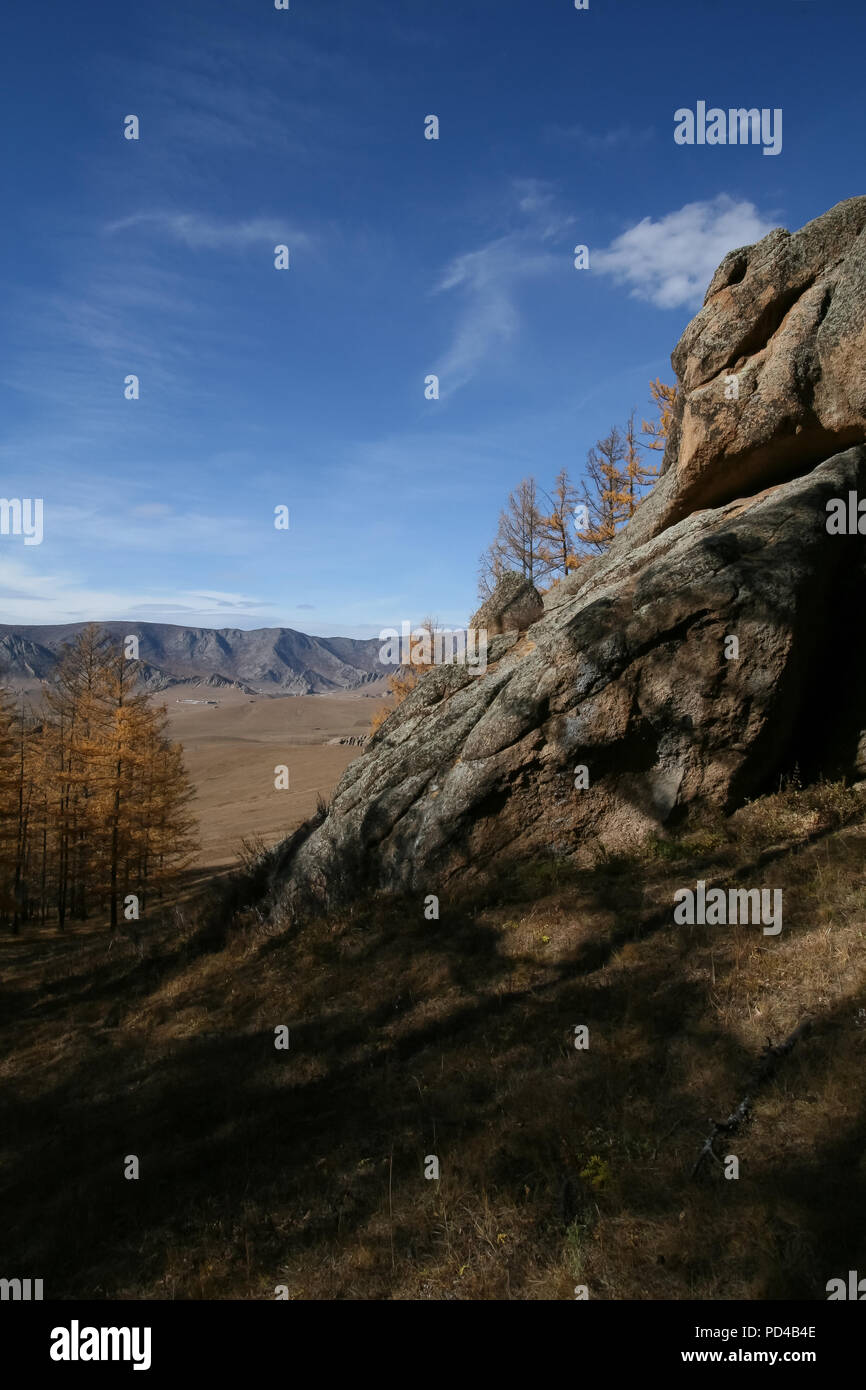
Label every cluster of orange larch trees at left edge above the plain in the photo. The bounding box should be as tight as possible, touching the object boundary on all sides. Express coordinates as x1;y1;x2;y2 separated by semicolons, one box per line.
0;624;195;931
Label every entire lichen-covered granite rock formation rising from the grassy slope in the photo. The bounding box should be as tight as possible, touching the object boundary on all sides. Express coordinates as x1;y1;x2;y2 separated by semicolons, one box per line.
275;197;866;901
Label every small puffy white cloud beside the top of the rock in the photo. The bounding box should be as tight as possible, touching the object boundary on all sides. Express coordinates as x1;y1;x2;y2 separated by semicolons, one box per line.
591;193;777;309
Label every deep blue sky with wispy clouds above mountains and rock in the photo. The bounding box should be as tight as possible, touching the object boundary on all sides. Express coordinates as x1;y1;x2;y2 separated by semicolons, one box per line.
0;0;866;637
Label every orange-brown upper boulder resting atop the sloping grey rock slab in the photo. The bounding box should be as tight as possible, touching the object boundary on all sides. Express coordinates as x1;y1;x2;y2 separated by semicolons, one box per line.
616;197;866;553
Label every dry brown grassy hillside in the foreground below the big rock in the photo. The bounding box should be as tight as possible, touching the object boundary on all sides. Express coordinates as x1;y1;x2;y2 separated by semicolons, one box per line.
0;785;866;1300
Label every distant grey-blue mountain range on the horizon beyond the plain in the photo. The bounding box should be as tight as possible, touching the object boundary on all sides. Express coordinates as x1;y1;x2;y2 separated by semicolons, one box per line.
0;623;388;695
